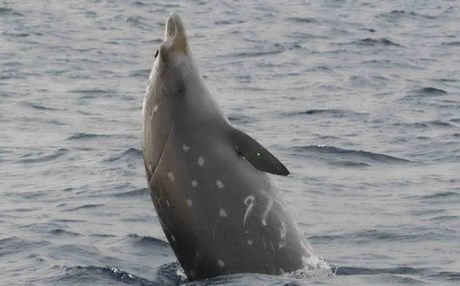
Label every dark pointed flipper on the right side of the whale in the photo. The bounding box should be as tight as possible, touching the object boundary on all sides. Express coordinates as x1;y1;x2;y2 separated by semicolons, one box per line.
232;129;289;176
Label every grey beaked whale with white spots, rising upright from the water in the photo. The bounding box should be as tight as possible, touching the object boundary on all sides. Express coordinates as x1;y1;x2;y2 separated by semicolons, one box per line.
142;13;311;280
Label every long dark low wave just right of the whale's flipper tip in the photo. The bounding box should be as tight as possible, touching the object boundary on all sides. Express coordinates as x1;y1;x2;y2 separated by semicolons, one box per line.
293;145;412;166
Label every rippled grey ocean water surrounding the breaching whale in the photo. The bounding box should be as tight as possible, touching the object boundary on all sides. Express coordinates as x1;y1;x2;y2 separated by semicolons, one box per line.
0;0;460;285
